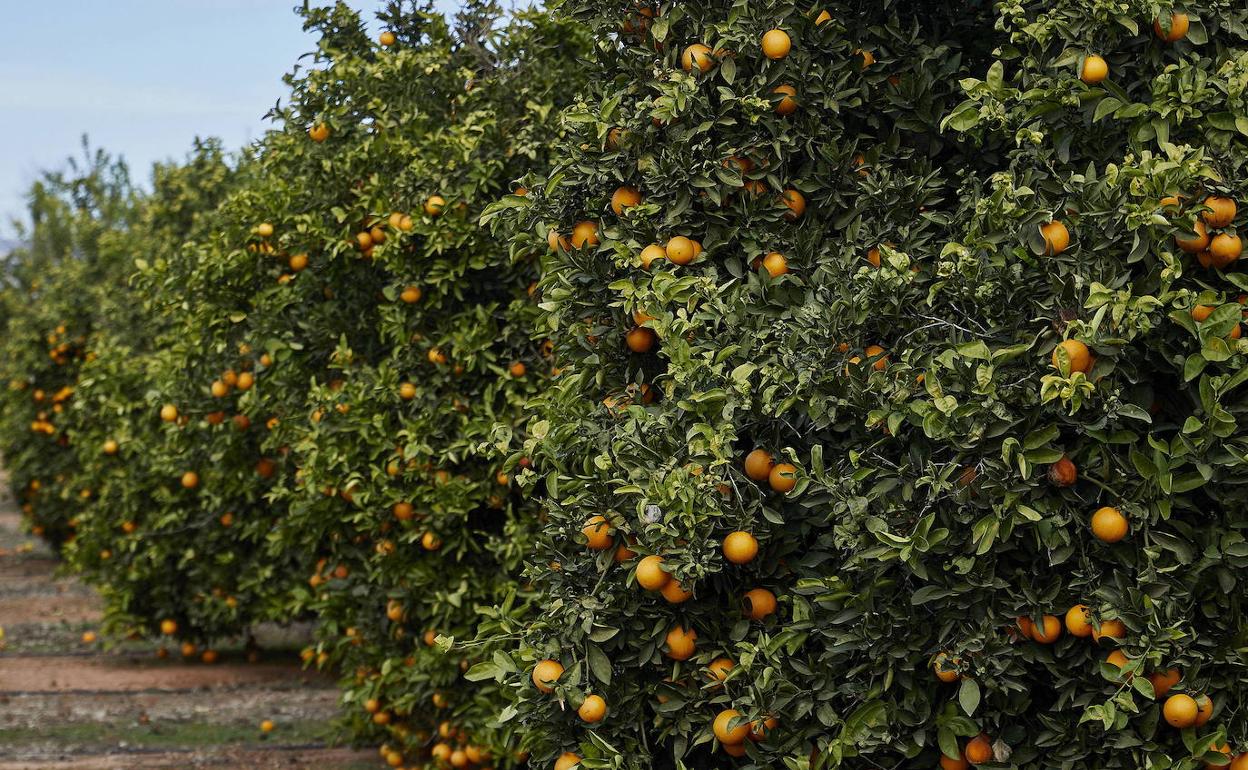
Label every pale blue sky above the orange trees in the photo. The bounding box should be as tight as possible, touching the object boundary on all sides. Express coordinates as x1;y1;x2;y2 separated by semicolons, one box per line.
0;0;459;240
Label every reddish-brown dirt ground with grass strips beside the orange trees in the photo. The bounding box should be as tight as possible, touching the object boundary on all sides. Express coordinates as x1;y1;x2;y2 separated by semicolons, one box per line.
0;489;379;770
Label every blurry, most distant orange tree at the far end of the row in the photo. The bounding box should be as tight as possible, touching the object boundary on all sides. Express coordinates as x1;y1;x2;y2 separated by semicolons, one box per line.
0;142;136;545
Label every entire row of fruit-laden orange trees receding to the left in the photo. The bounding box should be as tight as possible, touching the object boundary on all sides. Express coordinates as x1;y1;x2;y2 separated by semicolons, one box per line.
0;0;1248;770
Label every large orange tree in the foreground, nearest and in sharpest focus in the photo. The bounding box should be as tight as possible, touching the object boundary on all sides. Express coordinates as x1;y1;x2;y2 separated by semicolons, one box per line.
491;0;1248;769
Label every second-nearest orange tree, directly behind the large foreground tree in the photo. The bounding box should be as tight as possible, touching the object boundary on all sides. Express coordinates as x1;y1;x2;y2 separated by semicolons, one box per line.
102;2;584;763
